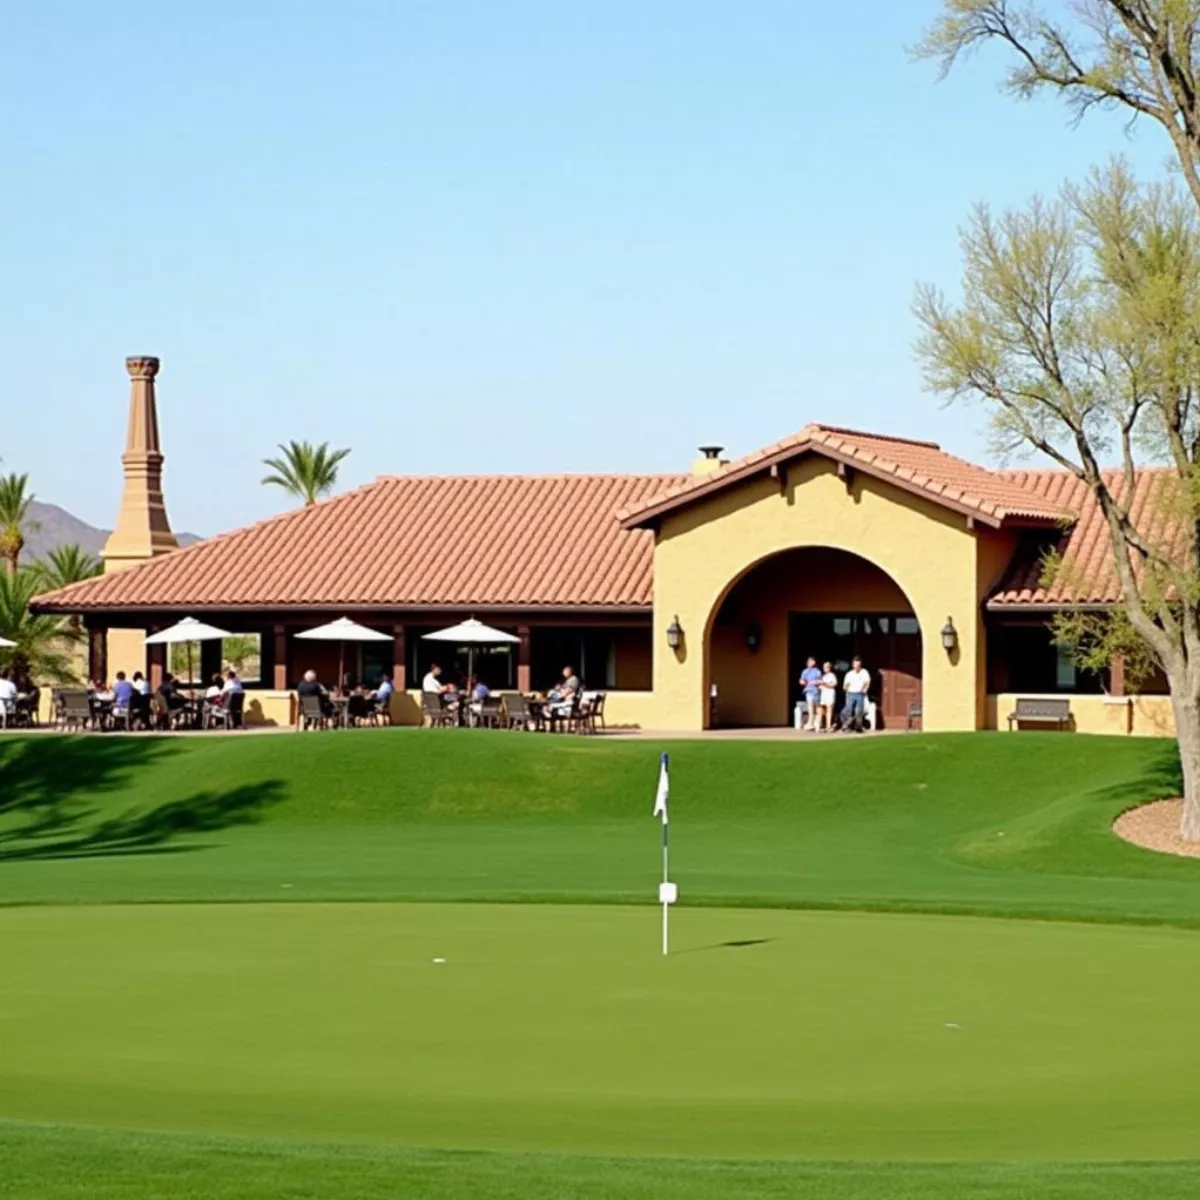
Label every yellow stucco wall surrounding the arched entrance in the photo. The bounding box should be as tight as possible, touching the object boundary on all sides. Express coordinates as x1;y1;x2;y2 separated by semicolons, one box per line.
654;457;1001;730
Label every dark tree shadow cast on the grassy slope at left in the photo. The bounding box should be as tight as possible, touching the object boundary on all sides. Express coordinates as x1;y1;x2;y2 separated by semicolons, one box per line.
0;737;284;862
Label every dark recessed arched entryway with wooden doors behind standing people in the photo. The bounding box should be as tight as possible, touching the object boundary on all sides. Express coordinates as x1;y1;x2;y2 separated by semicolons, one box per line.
704;546;922;728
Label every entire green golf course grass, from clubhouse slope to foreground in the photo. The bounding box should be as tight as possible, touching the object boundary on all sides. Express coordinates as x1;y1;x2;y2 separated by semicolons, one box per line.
0;731;1200;1200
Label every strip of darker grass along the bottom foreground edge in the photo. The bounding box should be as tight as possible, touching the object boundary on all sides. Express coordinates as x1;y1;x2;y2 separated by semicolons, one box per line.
0;1123;1200;1200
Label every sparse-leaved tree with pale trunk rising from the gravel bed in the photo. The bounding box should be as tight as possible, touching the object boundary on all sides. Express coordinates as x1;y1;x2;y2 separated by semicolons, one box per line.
914;161;1200;839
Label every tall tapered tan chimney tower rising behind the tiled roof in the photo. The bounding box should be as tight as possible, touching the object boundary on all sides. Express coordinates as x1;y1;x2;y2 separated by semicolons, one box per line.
103;354;179;572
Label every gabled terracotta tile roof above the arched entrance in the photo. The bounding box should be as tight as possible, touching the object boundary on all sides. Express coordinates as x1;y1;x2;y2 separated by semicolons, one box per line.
620;425;1066;528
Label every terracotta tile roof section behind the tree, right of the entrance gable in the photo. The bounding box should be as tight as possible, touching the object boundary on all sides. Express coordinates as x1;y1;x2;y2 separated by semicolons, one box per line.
988;469;1174;608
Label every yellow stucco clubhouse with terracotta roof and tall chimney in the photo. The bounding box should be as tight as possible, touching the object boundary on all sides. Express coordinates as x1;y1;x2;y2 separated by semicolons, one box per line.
35;358;1171;733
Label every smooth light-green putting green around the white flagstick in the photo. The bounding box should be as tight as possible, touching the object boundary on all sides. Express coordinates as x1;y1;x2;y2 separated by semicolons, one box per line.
0;904;1200;1160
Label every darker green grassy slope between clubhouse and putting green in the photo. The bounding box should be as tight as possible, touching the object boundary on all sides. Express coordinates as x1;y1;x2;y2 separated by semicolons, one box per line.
0;730;1200;924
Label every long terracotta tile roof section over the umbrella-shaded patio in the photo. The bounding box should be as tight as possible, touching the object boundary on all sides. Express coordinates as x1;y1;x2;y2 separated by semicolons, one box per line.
36;475;679;612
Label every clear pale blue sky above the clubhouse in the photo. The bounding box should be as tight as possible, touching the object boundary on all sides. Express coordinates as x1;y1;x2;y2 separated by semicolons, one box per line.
0;0;1166;534
